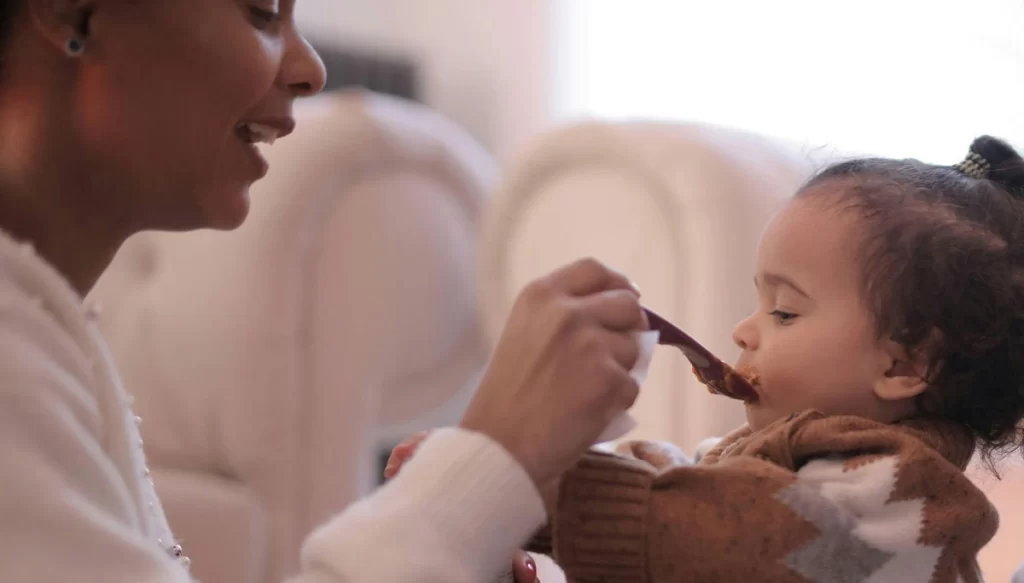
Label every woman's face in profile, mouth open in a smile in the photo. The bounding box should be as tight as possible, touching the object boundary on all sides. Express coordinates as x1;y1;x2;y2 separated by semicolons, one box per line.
73;0;325;230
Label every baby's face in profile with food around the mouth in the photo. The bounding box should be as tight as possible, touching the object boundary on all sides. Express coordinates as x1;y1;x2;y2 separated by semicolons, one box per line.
733;197;893;429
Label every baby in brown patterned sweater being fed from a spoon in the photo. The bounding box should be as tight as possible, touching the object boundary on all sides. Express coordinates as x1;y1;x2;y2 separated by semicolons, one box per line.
389;136;1024;583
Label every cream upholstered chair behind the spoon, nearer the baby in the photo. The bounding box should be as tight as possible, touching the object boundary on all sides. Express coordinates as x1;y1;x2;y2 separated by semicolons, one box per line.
480;123;810;449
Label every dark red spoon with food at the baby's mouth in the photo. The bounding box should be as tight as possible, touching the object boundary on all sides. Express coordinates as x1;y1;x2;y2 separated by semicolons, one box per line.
644;307;758;402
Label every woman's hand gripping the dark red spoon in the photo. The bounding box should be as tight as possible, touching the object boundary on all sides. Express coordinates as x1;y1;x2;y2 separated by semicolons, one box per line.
462;259;647;491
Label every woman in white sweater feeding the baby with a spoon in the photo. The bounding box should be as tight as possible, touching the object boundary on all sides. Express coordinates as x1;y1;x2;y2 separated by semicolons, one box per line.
0;0;645;583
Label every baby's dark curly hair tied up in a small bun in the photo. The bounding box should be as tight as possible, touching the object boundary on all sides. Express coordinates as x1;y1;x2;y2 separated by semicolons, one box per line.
797;135;1024;470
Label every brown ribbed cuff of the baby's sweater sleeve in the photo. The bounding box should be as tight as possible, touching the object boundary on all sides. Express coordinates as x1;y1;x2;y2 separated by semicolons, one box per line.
554;453;653;583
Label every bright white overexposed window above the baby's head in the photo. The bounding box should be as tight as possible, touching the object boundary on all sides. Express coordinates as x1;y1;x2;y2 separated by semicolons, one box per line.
555;0;1024;158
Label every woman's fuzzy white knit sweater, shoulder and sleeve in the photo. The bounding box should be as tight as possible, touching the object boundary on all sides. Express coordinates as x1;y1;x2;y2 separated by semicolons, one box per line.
0;228;545;583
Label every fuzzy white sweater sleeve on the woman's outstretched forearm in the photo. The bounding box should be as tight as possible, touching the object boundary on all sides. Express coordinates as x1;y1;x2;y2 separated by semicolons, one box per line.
303;422;545;583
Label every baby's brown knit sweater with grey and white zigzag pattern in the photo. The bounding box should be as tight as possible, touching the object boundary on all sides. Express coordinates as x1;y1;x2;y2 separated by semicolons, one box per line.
530;412;997;583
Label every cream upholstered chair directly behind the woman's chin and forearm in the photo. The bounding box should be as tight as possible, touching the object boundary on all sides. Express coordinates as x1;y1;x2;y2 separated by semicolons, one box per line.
92;92;495;583
